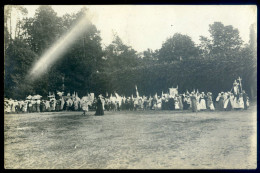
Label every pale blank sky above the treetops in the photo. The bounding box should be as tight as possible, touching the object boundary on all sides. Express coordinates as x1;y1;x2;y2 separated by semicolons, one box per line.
9;5;257;52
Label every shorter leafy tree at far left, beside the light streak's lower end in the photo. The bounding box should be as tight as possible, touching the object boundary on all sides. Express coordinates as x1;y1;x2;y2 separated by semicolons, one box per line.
4;38;37;99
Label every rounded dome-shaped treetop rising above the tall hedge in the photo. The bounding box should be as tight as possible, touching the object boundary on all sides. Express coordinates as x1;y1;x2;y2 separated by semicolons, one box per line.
158;33;198;62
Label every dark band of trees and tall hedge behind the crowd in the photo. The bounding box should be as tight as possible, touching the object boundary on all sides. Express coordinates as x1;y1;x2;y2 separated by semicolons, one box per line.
4;6;257;99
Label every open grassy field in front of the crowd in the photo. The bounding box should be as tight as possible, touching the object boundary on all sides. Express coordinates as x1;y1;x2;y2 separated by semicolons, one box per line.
4;106;257;169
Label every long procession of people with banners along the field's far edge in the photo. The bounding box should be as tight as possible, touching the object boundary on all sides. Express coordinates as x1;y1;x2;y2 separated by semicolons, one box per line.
4;77;249;114
